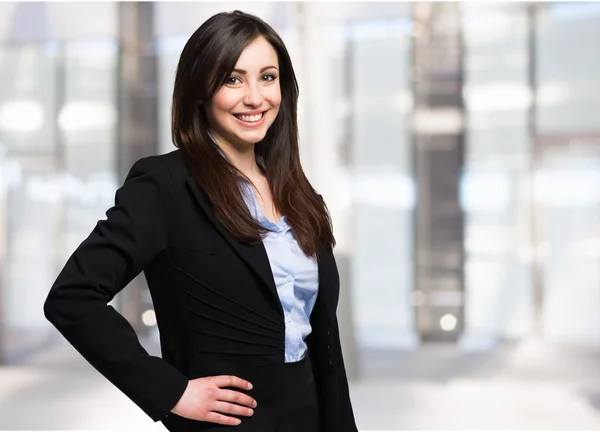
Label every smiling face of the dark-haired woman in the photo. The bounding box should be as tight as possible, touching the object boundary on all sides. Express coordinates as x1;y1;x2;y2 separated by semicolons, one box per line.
207;37;281;152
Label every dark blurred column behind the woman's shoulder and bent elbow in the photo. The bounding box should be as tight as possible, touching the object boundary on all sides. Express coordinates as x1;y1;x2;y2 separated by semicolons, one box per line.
116;2;158;334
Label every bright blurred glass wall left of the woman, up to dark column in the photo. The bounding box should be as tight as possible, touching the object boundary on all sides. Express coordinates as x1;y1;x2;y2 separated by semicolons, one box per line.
0;2;118;360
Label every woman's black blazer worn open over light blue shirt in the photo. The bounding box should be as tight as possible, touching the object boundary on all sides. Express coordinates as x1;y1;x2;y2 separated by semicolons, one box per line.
44;150;357;432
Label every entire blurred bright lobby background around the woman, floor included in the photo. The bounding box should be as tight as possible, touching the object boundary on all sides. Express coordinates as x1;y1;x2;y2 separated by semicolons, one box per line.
0;2;600;430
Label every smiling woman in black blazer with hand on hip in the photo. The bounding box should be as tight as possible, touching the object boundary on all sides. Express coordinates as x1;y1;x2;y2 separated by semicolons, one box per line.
44;11;357;432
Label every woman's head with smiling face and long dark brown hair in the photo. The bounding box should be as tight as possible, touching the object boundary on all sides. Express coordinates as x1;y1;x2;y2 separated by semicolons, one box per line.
172;11;335;256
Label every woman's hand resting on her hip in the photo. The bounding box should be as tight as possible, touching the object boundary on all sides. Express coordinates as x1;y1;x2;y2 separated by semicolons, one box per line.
171;375;256;426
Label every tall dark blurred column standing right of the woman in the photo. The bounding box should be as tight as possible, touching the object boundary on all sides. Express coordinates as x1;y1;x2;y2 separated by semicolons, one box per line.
412;2;465;341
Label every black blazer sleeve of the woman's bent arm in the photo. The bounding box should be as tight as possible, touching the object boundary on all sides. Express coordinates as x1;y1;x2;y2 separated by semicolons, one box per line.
44;157;189;421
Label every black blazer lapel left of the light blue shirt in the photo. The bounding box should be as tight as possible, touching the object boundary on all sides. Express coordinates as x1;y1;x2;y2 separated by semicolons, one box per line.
186;176;281;306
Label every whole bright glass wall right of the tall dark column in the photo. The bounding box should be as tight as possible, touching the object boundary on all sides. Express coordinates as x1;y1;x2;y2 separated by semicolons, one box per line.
462;2;600;344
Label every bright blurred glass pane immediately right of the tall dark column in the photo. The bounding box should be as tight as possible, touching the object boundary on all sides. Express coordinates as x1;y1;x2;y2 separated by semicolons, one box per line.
460;3;532;351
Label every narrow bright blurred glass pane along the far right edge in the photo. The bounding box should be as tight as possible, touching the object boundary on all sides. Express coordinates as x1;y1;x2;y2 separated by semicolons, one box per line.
534;2;600;344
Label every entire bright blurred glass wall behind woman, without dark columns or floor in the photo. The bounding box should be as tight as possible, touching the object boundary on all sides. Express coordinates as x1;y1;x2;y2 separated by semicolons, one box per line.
0;2;600;362
